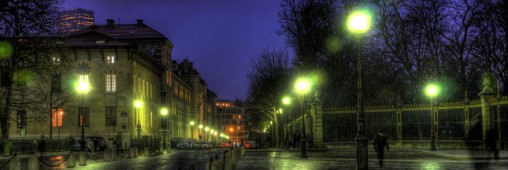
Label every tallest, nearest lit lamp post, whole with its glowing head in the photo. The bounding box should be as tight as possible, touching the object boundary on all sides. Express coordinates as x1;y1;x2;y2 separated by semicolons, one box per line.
347;10;370;169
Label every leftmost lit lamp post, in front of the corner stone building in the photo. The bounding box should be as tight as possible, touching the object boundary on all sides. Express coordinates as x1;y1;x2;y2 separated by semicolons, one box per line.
76;64;90;150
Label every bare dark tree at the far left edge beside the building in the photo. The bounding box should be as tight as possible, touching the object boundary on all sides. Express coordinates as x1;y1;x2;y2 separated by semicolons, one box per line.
0;0;60;138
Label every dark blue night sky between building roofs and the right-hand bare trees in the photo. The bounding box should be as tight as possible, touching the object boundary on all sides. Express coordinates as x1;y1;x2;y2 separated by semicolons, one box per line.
63;0;287;100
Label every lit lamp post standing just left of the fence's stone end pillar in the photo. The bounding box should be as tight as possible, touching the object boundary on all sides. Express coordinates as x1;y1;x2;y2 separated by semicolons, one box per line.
295;78;310;158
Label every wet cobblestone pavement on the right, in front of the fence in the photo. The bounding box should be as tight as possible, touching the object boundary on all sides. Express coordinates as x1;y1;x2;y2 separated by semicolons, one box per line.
235;151;508;170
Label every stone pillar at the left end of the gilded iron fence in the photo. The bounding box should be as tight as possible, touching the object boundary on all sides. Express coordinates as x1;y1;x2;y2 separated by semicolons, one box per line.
312;99;324;148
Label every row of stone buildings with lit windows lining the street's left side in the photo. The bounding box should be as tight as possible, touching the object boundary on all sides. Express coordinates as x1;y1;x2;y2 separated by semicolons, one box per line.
0;9;248;148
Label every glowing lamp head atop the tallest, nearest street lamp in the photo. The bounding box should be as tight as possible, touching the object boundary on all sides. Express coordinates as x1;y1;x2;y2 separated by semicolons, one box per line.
347;10;371;33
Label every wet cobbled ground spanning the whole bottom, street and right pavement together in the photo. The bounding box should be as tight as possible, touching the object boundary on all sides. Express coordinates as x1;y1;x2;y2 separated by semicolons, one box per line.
2;149;508;170
